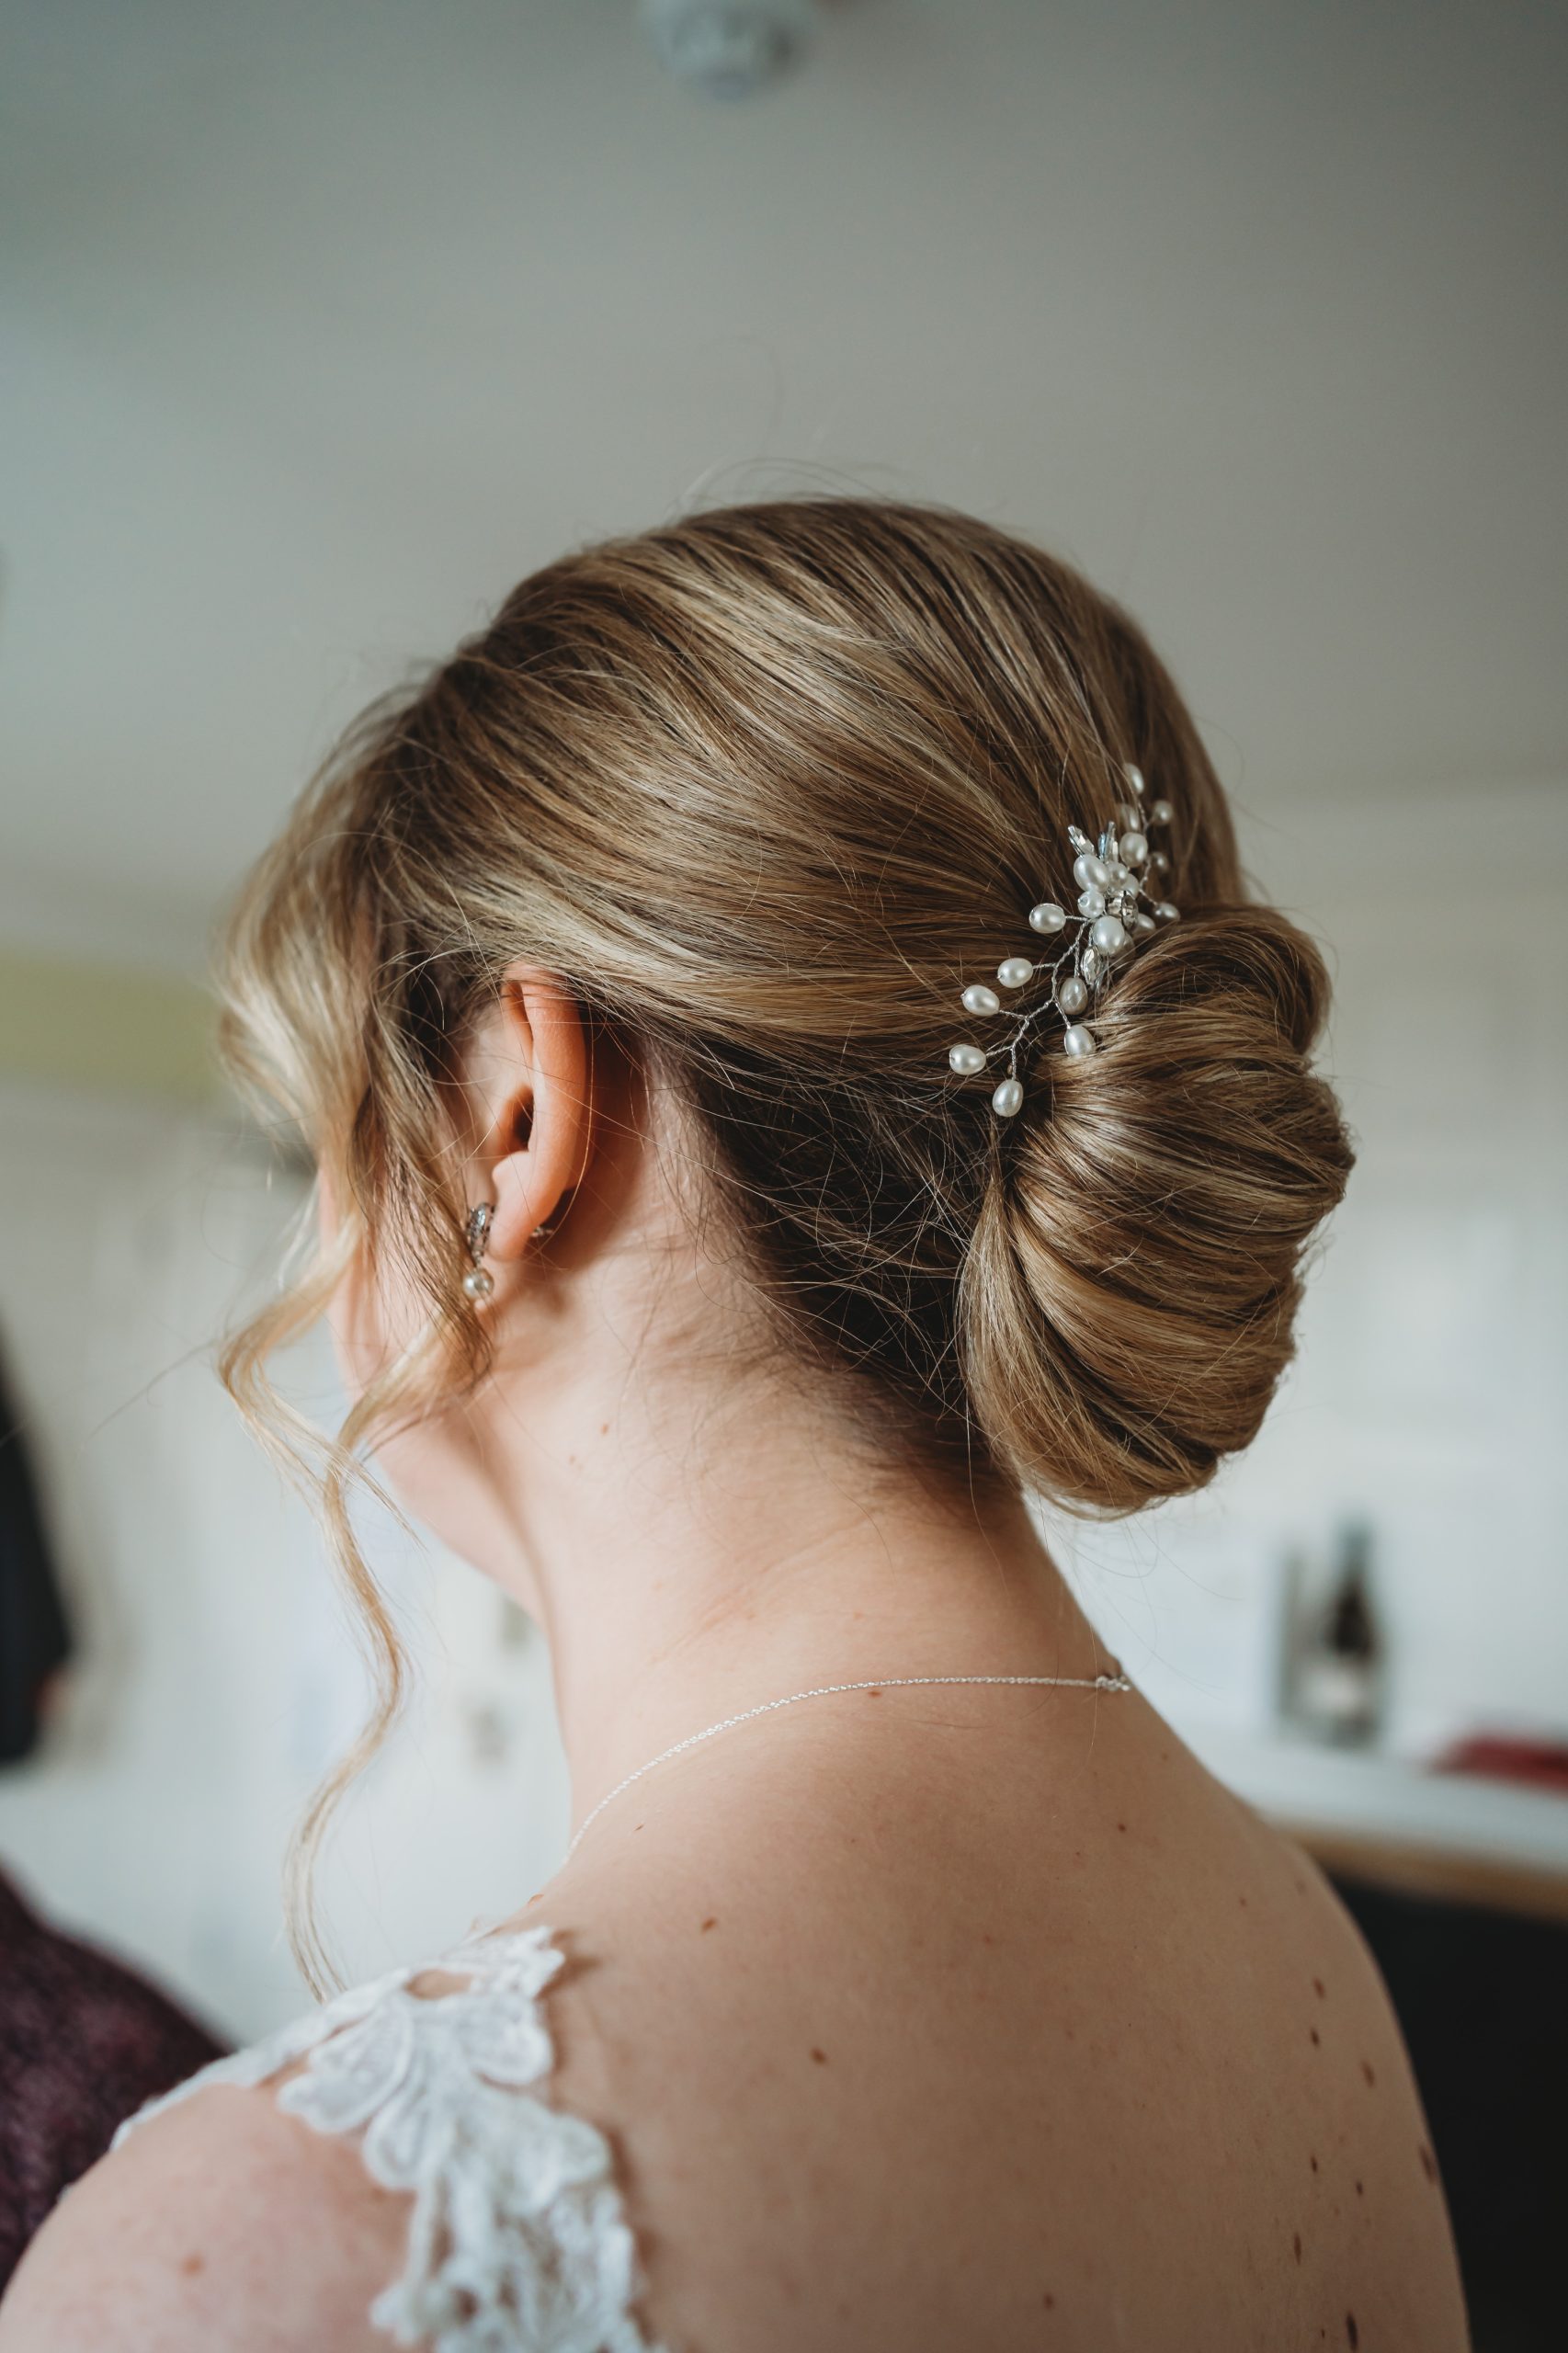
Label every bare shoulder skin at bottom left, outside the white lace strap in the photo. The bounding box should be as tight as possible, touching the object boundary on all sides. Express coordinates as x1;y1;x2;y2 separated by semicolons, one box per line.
0;2085;410;2353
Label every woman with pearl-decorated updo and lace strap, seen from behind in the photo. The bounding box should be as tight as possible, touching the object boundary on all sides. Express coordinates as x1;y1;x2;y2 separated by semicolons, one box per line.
0;501;1464;2353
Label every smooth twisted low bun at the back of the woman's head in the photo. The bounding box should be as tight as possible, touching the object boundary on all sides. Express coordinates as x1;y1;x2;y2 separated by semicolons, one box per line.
960;906;1351;1511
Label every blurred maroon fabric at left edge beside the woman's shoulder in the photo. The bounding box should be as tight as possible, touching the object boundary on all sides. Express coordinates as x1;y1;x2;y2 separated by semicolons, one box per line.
0;1878;219;2287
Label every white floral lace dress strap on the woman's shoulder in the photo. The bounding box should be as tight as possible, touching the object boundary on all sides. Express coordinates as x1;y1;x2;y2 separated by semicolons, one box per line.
116;1927;659;2353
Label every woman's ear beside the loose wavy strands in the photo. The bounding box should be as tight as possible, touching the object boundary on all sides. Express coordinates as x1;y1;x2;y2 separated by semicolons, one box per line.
473;965;594;1261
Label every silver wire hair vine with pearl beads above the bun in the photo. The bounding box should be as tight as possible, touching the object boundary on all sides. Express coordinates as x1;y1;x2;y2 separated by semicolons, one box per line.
947;765;1177;1120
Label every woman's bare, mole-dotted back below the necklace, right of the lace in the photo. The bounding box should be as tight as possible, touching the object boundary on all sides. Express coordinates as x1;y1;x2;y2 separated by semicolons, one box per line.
549;1694;1467;2353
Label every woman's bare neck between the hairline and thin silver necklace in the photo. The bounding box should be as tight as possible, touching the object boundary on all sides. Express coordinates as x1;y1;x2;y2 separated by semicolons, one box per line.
451;1317;1107;1826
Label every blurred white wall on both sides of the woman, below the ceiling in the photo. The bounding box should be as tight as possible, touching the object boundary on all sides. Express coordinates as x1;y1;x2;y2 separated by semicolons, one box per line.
0;789;1568;2033
